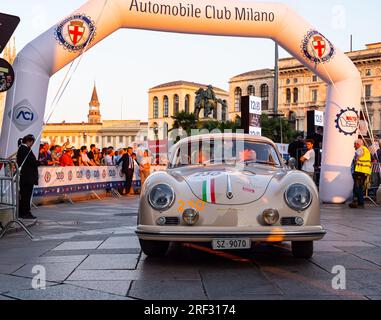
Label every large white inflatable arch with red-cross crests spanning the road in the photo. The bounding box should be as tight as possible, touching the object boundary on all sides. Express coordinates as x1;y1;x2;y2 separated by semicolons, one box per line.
0;0;361;203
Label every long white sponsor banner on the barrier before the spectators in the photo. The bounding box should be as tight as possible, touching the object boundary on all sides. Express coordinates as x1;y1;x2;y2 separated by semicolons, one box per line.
33;166;141;197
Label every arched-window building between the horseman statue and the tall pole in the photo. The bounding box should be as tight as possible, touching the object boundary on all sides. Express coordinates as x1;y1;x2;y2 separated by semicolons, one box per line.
229;69;274;120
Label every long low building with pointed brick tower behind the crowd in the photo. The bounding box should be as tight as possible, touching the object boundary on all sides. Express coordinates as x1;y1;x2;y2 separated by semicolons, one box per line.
42;85;148;148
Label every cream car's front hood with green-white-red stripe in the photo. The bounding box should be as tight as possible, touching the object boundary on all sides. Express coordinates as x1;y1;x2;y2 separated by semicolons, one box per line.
170;166;280;205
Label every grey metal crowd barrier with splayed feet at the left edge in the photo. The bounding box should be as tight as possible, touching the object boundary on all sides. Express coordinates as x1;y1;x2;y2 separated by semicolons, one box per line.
0;159;34;239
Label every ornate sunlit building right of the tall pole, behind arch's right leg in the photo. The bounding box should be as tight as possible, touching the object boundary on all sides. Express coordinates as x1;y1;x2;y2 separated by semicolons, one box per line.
279;43;381;135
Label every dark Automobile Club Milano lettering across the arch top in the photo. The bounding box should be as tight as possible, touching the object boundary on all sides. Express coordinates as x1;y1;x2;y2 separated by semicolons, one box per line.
130;0;275;22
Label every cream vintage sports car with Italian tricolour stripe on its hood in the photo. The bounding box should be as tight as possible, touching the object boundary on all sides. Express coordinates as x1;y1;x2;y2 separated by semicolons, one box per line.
136;134;326;258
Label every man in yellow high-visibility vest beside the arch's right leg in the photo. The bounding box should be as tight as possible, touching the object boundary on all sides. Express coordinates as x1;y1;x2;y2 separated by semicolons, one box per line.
349;139;372;208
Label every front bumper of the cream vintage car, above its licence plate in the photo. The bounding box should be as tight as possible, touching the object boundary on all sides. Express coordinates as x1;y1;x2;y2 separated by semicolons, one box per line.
135;226;326;242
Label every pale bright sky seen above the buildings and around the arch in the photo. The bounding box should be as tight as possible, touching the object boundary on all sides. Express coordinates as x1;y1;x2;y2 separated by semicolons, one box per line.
0;0;381;122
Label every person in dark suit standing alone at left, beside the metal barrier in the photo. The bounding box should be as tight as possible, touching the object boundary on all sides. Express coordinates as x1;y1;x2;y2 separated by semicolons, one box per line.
17;135;38;220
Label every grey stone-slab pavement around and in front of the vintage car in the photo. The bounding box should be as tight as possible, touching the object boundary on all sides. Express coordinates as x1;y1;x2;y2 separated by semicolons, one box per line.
0;198;381;300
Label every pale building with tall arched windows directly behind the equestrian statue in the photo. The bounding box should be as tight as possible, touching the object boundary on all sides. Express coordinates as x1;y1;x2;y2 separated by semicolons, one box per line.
148;81;229;137
